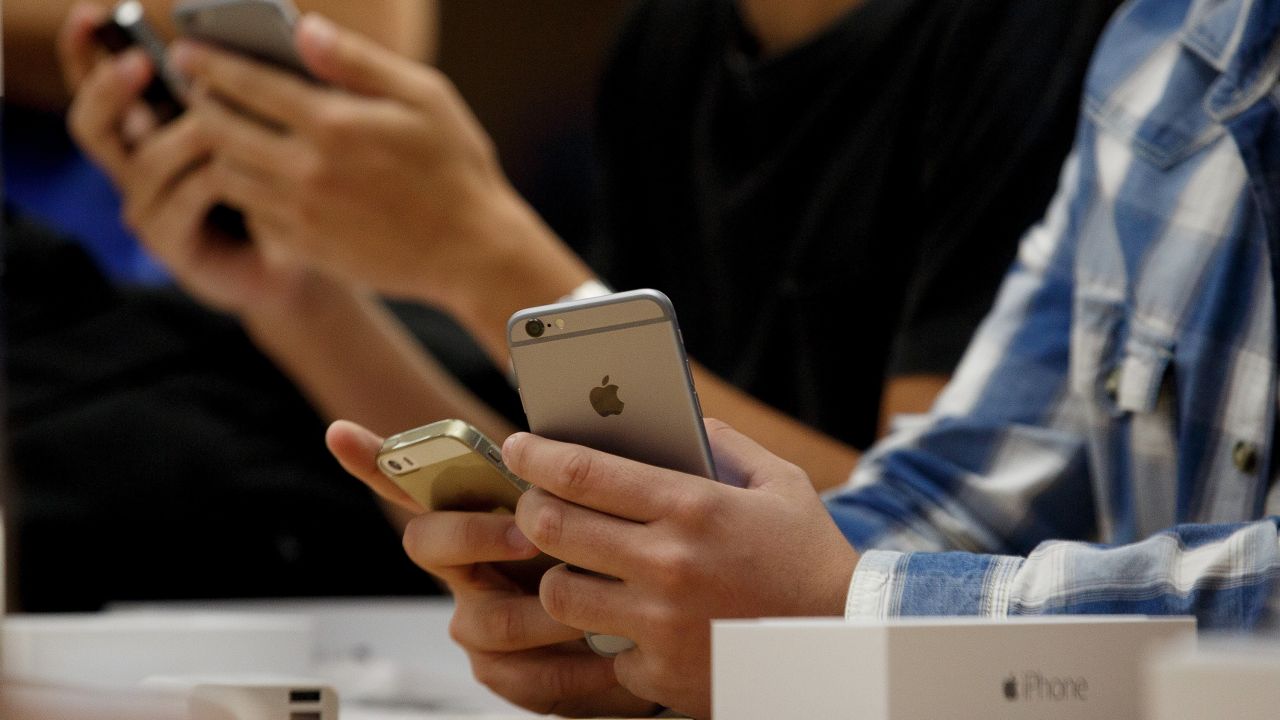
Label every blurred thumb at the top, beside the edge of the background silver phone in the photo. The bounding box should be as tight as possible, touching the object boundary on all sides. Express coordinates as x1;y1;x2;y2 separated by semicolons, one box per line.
294;13;422;102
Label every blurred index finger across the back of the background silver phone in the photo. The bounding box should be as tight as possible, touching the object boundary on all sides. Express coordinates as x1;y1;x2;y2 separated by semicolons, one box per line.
169;40;319;128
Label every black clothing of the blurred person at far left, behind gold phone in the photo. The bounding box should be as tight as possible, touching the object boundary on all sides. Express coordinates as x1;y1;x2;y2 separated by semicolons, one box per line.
0;211;450;611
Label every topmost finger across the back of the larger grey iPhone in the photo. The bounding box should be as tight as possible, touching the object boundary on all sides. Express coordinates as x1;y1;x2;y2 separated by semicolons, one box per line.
502;433;714;523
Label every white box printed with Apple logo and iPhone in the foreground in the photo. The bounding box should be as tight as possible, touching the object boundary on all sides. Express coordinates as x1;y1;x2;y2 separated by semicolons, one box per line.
712;616;1196;720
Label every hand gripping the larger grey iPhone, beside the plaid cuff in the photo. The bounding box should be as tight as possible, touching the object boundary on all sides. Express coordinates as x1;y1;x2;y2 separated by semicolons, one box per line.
503;420;858;717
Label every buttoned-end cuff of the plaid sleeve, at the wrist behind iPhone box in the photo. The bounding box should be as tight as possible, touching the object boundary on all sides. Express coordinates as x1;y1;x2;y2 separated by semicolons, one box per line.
845;550;1023;620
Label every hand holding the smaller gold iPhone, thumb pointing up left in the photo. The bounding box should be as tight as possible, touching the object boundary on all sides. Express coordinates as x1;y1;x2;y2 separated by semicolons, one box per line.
325;420;655;716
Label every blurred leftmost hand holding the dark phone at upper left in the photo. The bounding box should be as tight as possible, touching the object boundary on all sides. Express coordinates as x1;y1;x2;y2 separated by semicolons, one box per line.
59;4;307;314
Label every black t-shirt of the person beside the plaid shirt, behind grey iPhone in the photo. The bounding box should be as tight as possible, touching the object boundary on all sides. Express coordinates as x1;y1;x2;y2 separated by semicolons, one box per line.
593;0;1117;447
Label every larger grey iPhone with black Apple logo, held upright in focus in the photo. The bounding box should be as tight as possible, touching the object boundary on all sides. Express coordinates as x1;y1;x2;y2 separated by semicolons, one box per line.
507;290;716;655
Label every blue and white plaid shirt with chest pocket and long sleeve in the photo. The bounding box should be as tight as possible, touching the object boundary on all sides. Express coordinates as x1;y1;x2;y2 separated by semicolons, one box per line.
828;0;1280;628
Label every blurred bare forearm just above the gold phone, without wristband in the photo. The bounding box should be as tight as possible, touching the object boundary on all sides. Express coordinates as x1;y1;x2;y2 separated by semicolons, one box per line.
242;270;513;442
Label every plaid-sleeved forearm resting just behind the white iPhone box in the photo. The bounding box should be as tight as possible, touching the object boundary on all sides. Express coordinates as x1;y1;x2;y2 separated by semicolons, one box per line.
846;518;1280;630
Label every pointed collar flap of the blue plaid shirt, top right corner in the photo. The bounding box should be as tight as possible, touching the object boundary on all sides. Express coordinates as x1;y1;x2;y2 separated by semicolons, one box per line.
1181;0;1280;118
